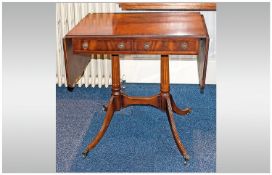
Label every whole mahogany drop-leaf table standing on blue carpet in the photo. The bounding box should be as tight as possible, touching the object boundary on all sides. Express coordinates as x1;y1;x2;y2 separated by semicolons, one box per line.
63;12;209;162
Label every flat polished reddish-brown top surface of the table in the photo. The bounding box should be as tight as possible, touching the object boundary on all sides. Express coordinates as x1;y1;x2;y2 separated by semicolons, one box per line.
66;12;208;38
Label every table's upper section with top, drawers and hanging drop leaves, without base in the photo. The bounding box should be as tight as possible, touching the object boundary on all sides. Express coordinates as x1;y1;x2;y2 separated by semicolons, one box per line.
64;12;209;89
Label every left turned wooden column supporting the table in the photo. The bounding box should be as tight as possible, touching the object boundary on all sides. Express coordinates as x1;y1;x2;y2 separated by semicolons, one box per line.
111;55;122;111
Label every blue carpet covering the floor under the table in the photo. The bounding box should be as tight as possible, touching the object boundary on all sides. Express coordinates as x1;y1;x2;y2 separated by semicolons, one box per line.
57;84;216;172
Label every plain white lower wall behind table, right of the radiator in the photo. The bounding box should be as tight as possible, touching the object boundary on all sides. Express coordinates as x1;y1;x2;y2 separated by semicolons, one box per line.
121;55;216;84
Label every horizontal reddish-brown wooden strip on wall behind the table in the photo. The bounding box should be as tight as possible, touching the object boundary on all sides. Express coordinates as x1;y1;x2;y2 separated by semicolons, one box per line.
119;3;216;11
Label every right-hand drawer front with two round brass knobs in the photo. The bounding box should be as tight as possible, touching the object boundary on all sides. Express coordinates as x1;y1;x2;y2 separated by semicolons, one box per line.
134;39;198;54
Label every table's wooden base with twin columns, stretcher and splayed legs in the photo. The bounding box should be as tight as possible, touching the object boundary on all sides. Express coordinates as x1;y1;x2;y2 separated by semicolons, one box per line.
82;55;191;162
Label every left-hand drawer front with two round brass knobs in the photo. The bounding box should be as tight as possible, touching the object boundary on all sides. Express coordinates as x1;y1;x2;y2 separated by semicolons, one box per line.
73;39;132;51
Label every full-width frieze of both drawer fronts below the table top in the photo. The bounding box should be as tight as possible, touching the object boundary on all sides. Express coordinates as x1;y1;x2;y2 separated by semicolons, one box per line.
73;38;199;55
